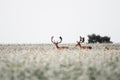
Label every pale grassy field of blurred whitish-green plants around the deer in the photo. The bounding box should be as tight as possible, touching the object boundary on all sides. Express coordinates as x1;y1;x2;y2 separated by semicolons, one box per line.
0;44;120;80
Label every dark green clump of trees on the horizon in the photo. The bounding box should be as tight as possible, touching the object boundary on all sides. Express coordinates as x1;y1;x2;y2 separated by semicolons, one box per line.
88;34;111;43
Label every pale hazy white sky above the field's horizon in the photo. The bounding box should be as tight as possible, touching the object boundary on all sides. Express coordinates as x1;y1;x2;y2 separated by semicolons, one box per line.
0;0;120;44
